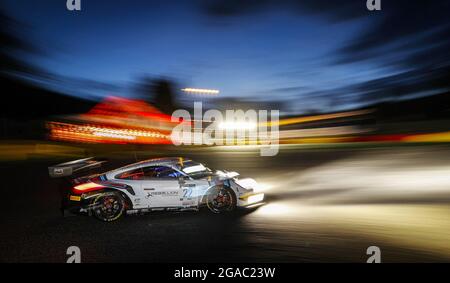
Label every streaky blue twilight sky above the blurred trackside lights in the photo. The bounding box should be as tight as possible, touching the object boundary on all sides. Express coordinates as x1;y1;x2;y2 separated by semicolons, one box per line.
4;0;446;113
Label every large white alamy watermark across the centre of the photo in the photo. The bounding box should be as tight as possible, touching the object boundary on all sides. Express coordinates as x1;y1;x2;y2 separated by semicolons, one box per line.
171;102;280;156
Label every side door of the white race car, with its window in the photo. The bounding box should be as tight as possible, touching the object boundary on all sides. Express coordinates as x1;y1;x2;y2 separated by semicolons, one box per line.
142;166;182;208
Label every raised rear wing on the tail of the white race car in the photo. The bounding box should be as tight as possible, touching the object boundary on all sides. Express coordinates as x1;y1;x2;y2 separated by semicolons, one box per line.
48;157;106;178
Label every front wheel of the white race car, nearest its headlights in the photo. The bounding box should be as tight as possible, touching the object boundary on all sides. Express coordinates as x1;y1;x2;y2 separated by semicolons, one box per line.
206;186;237;214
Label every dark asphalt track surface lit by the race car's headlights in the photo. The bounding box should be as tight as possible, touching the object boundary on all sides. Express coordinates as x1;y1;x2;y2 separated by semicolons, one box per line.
0;146;450;262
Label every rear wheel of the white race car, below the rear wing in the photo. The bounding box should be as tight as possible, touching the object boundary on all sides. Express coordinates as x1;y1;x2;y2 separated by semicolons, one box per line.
92;192;126;222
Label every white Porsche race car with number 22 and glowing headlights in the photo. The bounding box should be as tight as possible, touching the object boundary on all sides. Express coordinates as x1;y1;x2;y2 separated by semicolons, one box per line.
49;157;264;221
